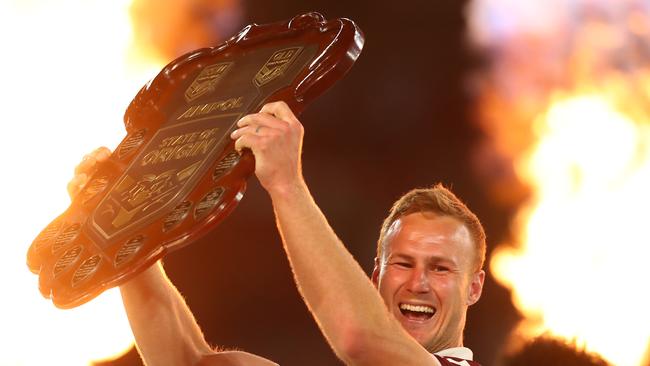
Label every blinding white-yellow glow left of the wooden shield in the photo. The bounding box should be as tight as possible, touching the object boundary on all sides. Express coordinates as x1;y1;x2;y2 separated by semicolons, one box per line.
0;0;161;366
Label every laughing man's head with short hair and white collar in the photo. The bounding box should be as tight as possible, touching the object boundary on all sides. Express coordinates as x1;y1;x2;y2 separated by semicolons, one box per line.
372;189;485;361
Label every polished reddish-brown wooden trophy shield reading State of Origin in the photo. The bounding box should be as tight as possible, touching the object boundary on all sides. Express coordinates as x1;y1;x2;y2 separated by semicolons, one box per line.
27;13;364;308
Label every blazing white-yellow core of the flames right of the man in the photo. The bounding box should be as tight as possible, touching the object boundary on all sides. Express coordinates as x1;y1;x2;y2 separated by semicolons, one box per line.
491;95;650;366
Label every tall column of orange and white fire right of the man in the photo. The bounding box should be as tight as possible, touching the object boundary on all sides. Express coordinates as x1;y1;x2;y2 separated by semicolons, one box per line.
469;0;650;366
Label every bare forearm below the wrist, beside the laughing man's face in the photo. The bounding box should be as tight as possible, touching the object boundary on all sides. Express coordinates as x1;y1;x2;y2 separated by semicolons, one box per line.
271;182;428;365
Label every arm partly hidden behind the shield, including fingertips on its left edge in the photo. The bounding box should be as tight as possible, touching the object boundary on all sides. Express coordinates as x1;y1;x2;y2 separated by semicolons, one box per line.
68;148;277;366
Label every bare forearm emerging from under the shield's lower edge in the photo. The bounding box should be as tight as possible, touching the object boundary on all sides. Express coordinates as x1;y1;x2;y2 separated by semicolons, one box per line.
120;262;210;366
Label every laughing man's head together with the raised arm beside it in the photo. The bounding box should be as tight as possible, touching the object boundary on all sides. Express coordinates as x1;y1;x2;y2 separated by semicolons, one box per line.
232;102;485;366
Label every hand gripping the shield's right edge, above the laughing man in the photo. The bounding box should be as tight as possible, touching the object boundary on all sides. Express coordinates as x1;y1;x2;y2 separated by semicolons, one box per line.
231;101;304;194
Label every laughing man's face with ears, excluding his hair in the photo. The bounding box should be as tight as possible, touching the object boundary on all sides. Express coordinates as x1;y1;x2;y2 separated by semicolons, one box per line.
372;213;485;352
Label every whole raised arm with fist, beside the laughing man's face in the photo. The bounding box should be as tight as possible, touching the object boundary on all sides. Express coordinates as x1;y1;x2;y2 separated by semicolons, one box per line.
232;102;438;366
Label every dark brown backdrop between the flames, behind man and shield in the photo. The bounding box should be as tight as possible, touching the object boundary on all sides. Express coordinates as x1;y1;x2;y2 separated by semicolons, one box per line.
106;0;518;366
